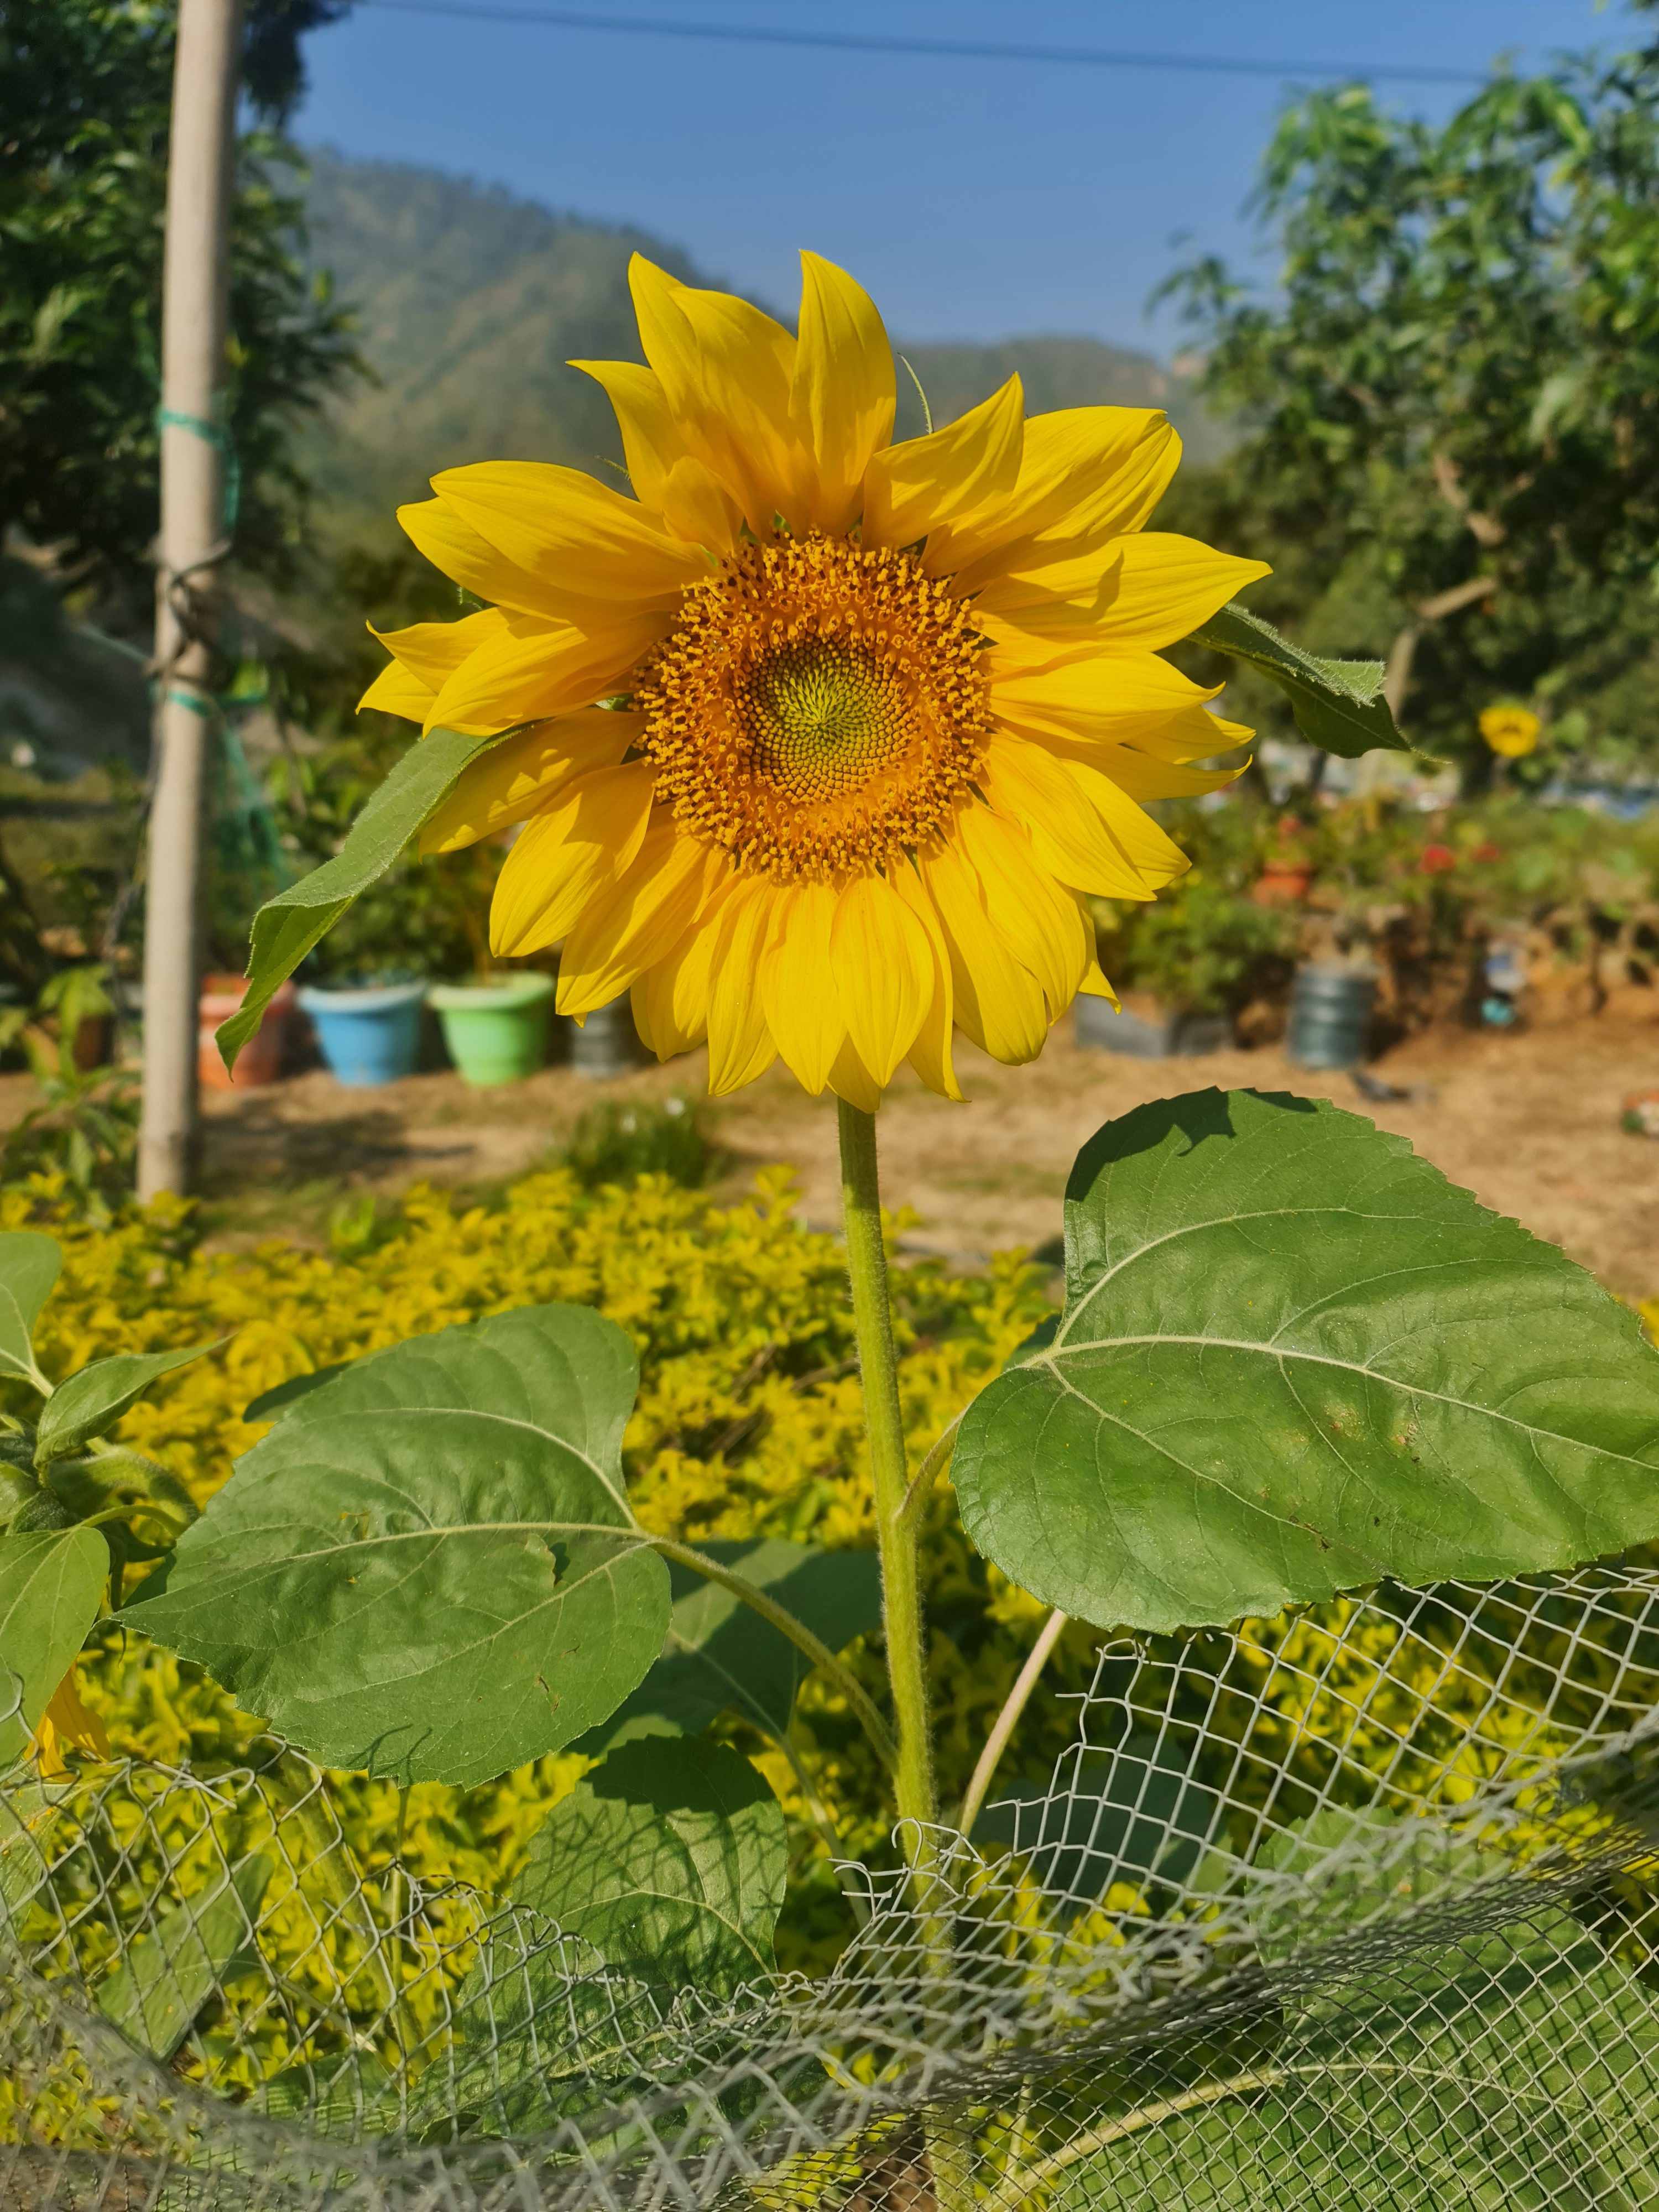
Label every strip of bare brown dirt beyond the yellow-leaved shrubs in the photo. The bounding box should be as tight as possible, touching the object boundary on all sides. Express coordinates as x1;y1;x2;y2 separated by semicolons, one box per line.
0;1015;1659;1294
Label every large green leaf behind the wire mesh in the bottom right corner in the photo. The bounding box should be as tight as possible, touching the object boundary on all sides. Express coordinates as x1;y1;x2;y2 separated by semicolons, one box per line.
1042;1809;1659;2212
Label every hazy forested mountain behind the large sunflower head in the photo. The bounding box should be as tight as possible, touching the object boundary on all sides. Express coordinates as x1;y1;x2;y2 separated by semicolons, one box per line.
305;153;1219;535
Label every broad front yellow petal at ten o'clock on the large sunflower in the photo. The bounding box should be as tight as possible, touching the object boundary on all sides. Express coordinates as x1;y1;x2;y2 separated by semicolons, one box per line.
431;460;708;606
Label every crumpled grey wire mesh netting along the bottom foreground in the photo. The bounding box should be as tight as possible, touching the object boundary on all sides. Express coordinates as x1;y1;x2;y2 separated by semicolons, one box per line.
0;1568;1659;2212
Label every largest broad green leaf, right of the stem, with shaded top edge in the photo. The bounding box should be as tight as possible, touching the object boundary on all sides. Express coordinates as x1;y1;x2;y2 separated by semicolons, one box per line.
951;1091;1659;1630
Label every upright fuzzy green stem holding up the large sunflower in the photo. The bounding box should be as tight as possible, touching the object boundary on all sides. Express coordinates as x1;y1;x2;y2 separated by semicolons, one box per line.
836;1099;973;2212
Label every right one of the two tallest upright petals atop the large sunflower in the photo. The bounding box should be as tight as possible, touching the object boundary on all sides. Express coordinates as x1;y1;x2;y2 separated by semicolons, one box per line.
785;254;894;540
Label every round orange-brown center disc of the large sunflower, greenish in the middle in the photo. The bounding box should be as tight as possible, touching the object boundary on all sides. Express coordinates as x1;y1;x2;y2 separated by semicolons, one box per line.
633;538;989;880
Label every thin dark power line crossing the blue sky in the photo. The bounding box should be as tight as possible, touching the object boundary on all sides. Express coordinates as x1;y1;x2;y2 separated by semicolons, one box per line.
358;0;1486;84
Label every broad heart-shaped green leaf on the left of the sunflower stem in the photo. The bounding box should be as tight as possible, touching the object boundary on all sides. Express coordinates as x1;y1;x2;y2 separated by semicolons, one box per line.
119;1305;668;1783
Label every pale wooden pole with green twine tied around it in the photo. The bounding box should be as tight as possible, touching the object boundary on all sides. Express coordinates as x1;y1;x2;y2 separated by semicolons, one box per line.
137;0;241;1199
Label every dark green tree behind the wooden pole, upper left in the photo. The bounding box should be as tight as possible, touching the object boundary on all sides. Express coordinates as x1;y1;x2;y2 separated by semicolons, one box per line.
0;0;354;630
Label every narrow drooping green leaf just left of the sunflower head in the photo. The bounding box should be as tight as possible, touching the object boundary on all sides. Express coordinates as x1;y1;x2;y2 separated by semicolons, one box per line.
217;726;524;1068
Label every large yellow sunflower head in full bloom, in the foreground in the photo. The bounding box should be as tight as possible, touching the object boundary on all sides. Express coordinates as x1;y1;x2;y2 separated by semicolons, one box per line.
363;254;1265;1108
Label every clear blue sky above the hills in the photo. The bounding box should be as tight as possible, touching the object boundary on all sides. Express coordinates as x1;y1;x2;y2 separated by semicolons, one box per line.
296;0;1655;352
